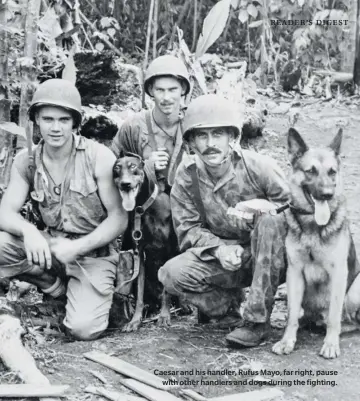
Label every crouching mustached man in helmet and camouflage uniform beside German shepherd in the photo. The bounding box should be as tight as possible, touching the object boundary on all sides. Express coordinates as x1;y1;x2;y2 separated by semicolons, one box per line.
158;95;289;347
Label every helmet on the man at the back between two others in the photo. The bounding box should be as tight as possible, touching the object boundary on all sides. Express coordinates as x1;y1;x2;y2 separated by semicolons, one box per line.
144;55;190;96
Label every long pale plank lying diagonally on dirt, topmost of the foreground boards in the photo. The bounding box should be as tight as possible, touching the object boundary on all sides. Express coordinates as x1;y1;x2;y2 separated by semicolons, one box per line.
84;351;174;390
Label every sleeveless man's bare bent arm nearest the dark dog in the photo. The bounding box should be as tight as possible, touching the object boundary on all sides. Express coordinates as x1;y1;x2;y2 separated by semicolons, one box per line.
73;147;128;255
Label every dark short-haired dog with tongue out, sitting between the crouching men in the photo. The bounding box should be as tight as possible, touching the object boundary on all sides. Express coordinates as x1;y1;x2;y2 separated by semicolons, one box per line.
113;153;177;332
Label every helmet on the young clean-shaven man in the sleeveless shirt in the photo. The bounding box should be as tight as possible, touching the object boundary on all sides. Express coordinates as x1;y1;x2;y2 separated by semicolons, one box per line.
28;78;82;127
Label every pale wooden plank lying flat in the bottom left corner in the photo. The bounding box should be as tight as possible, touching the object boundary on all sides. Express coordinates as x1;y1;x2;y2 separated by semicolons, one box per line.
0;384;69;400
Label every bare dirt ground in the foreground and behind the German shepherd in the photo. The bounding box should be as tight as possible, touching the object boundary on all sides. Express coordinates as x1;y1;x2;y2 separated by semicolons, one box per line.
0;99;360;401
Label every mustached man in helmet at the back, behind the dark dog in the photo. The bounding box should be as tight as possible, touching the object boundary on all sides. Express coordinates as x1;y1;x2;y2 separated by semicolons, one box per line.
111;55;190;192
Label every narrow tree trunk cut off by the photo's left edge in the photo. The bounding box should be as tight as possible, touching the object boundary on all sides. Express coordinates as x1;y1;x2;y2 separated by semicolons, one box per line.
0;2;14;189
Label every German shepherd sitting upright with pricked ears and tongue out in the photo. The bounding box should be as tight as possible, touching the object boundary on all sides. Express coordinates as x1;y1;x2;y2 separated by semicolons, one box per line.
272;128;360;358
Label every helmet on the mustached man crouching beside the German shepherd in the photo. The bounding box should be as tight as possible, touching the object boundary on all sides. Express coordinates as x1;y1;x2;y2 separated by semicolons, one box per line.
183;95;242;141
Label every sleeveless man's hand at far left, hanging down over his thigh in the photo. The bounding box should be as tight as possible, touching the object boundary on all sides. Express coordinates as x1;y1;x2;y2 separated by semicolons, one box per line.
23;224;51;269
